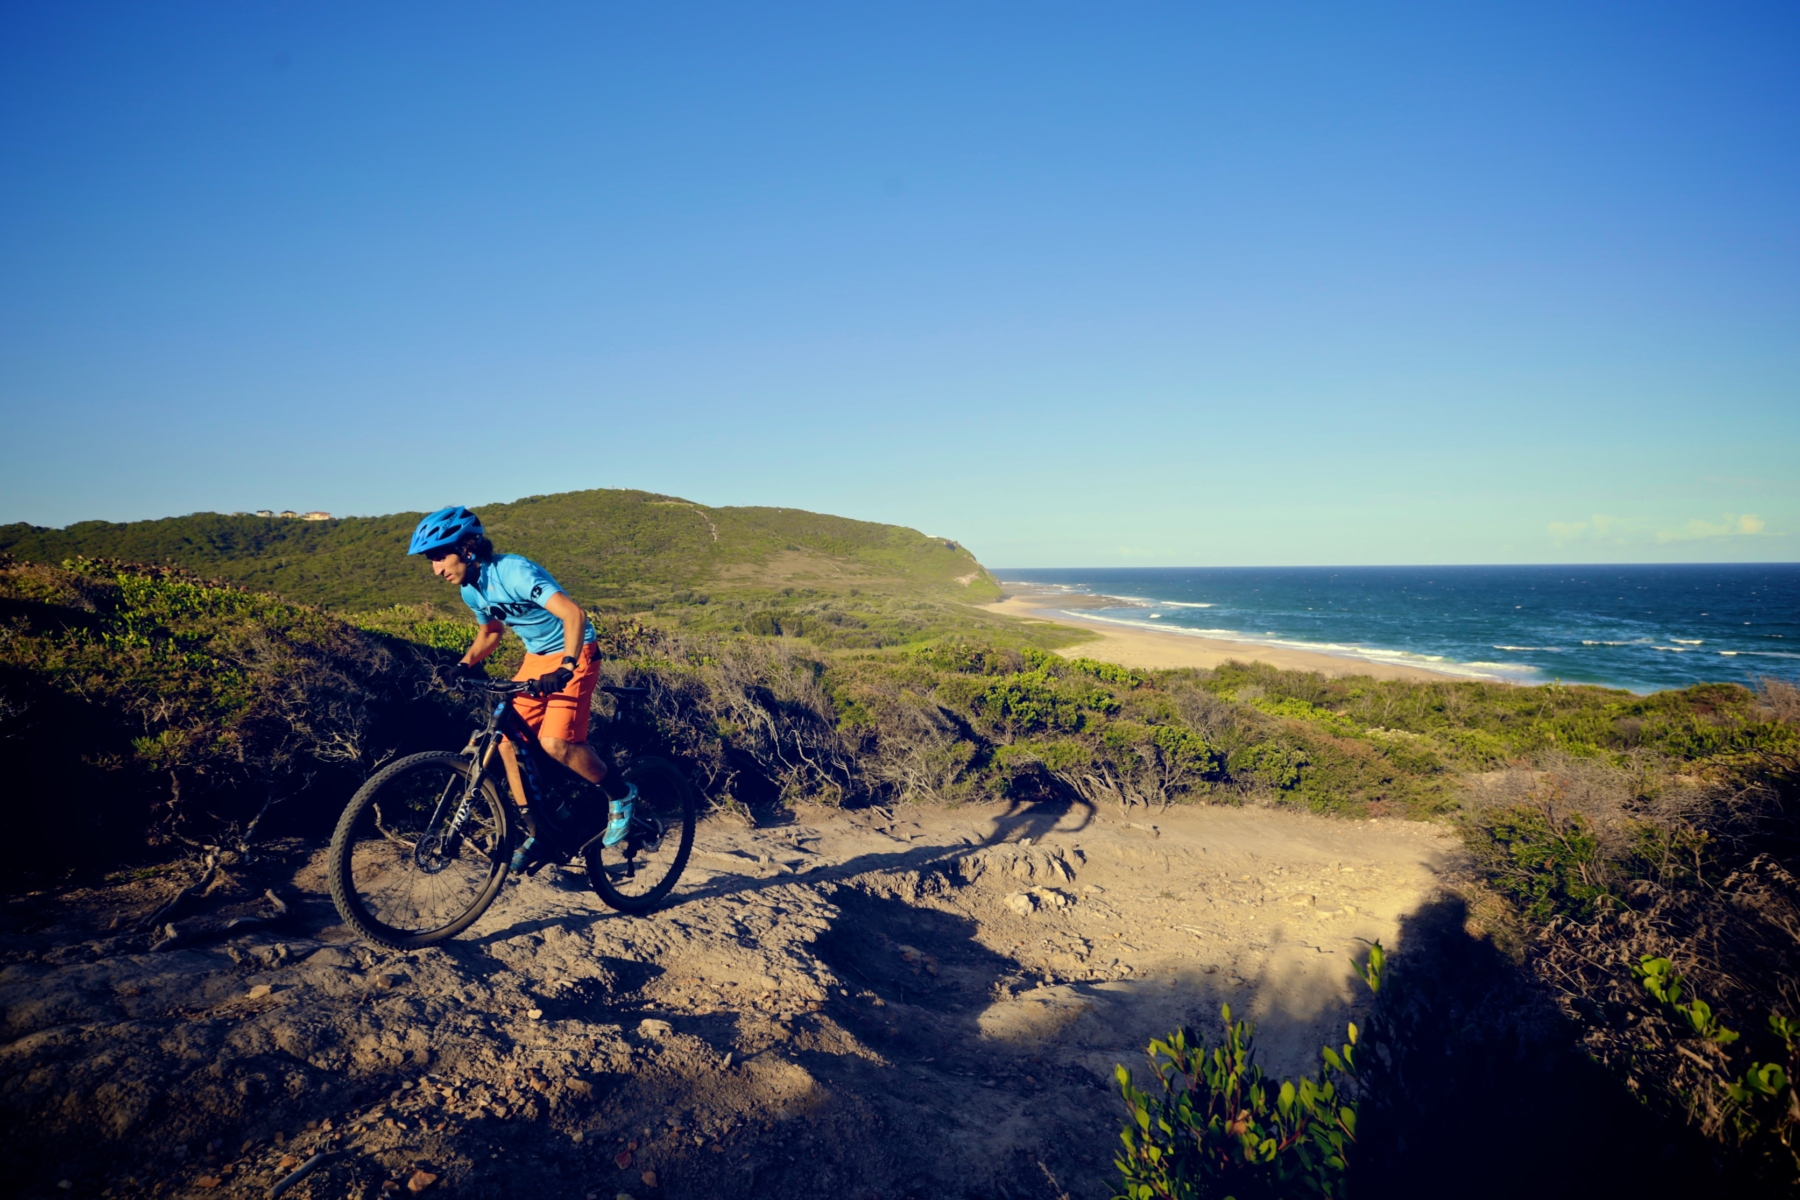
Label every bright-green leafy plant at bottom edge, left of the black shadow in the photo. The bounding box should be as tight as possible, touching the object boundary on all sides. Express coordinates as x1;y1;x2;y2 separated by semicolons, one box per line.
1114;943;1384;1200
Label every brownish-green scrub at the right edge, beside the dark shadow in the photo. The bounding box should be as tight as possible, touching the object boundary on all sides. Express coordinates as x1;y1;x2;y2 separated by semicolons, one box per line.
1462;687;1800;1187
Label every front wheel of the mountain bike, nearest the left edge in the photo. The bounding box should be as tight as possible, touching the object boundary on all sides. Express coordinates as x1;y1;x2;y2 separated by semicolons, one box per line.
326;752;509;950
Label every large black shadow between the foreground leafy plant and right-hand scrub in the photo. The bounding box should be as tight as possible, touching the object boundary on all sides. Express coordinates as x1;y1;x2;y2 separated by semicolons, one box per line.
1350;898;1748;1200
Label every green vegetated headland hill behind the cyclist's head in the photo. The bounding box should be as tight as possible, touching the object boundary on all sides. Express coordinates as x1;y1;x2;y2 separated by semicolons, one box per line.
0;489;999;612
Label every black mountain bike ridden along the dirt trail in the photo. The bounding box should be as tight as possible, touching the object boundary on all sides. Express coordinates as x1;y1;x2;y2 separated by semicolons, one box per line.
326;680;698;950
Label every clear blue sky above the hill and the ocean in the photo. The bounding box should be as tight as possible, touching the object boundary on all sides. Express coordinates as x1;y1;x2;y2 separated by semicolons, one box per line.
0;4;1800;567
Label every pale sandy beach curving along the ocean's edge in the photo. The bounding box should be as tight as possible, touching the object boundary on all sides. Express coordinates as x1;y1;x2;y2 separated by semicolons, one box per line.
983;588;1460;680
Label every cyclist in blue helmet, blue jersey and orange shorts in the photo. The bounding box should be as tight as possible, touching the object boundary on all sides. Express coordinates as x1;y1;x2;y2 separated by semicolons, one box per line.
407;506;637;859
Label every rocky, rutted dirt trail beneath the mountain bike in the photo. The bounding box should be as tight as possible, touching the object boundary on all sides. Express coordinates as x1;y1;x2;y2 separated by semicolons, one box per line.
0;808;1453;1200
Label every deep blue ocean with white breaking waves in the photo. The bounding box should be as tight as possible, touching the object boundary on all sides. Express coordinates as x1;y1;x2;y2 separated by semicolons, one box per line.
995;563;1800;693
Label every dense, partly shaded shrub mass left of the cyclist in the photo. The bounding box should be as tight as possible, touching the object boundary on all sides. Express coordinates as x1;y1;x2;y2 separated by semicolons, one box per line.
0;560;452;871
